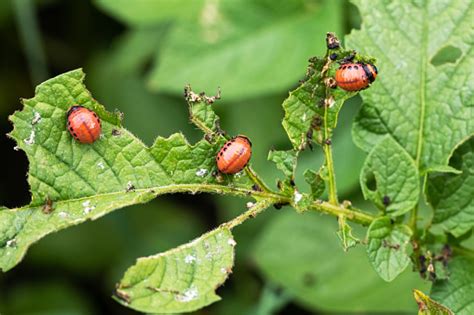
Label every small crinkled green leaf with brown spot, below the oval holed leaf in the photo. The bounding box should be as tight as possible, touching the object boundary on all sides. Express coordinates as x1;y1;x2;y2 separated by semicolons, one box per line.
367;217;412;281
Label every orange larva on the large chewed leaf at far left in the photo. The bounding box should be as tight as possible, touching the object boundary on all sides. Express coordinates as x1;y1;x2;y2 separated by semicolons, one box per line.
67;105;101;143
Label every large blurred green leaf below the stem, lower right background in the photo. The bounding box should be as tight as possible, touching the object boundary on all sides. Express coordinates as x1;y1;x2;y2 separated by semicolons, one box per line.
252;212;429;314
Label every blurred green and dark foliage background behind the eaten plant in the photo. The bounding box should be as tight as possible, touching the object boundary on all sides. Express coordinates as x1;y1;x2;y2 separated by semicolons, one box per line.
0;0;427;315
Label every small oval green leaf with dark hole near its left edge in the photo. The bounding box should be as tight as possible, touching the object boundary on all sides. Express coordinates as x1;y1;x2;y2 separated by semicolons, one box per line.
360;136;420;216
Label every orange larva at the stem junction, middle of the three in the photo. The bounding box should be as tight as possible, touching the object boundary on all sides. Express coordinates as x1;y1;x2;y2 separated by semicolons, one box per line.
216;136;252;174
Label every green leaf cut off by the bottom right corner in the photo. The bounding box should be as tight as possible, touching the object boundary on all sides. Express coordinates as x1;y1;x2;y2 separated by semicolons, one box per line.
430;256;474;315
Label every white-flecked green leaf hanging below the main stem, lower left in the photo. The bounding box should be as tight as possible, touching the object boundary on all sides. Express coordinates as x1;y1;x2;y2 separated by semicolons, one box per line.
115;228;236;313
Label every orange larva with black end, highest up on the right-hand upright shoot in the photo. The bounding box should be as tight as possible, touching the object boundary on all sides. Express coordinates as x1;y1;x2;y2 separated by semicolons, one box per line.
336;63;378;91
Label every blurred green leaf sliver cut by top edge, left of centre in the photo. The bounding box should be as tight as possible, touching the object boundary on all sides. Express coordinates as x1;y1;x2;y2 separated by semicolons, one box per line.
95;0;206;27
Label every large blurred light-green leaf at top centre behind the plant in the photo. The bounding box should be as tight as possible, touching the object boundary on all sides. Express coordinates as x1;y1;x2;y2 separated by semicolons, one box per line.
149;0;341;100
